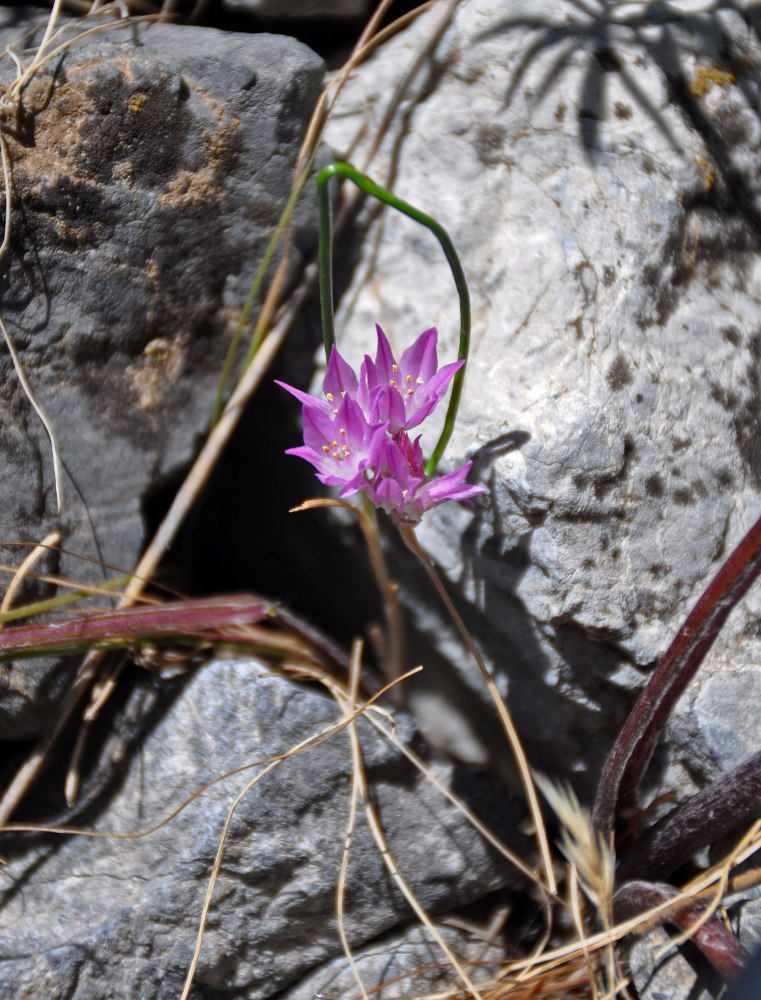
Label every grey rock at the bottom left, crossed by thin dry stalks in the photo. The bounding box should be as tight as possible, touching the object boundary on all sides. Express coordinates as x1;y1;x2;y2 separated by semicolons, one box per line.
0;660;515;1000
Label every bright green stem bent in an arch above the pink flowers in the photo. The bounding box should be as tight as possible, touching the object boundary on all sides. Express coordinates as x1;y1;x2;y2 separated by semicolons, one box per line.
317;163;470;476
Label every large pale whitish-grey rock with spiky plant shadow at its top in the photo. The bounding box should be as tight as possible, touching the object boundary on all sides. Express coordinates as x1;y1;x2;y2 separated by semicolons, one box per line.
328;0;761;795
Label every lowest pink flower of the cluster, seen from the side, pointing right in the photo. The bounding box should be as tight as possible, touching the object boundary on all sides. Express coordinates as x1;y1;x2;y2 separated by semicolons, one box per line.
363;431;486;524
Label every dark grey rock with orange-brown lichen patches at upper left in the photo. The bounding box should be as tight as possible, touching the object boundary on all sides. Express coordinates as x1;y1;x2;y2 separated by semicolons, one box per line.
0;8;322;739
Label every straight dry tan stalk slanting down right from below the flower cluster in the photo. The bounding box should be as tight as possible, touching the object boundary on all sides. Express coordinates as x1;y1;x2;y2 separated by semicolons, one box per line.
399;526;557;896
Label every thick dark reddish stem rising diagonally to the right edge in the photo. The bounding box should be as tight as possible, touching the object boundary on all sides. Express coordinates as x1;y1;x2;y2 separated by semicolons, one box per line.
593;508;761;837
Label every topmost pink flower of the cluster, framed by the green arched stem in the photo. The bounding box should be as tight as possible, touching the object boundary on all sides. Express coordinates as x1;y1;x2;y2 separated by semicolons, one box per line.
358;324;465;434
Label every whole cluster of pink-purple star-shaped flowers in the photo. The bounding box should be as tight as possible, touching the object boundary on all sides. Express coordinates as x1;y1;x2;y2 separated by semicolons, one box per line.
278;326;485;524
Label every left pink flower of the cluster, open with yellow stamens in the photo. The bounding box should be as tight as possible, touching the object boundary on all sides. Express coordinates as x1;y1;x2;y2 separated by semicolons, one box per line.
286;393;386;497
